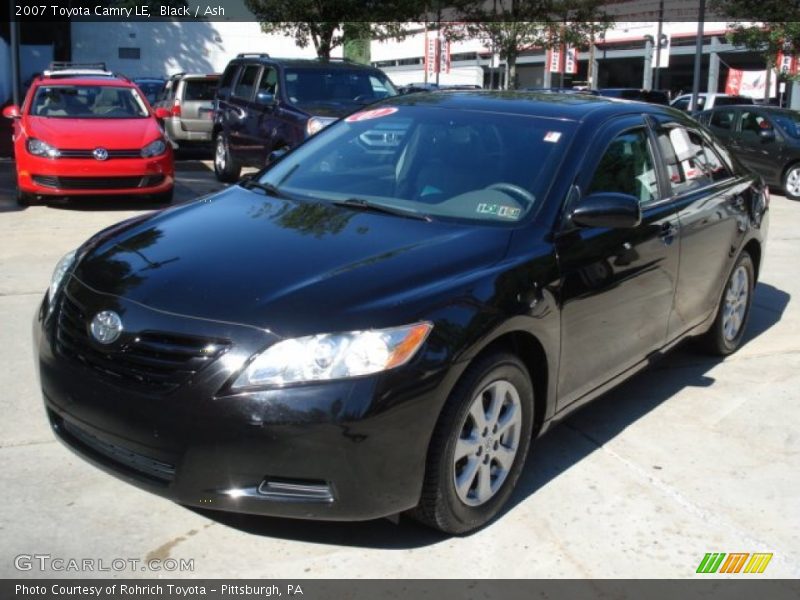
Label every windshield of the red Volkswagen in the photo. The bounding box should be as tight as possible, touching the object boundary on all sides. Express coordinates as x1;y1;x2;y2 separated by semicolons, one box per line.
30;85;148;119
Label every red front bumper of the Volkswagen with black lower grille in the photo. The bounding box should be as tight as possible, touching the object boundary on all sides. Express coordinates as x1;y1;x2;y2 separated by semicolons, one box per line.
17;148;175;196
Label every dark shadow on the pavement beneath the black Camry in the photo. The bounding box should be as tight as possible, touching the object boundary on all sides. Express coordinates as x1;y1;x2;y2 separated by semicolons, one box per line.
187;283;791;550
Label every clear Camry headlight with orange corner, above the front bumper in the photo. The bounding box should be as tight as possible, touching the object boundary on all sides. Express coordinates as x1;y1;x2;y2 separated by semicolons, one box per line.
233;323;433;389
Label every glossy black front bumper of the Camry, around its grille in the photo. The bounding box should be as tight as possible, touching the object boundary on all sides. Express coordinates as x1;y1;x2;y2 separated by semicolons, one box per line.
34;278;451;520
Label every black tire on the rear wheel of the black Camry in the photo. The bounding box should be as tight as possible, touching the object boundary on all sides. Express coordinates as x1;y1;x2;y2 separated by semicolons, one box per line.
700;251;755;356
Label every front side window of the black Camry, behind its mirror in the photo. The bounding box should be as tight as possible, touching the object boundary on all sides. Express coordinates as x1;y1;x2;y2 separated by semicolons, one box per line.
588;128;658;205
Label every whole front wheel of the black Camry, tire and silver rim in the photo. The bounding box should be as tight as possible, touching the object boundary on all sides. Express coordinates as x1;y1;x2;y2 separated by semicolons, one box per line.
411;353;534;534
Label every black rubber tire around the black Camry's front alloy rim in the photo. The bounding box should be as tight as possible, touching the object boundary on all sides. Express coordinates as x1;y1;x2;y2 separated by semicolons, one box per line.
410;352;534;534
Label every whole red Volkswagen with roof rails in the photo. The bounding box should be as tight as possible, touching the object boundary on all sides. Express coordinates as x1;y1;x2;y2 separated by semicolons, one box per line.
3;63;175;205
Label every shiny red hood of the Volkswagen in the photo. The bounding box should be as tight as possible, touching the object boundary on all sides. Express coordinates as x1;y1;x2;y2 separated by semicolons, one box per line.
27;117;162;150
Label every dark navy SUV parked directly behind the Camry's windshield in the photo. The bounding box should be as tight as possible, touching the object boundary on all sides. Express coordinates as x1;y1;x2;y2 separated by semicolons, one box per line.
213;54;397;182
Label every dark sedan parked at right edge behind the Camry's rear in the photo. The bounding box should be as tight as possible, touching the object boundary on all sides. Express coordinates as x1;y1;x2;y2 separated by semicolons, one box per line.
698;106;800;200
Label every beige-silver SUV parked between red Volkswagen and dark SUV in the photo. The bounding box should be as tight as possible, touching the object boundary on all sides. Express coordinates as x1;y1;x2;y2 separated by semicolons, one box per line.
156;73;220;148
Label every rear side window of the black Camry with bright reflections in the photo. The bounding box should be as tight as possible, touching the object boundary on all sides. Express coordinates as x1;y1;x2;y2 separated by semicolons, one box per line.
658;125;730;194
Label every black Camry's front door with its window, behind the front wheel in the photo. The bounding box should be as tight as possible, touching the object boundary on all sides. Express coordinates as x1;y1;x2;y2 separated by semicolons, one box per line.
556;116;680;408
